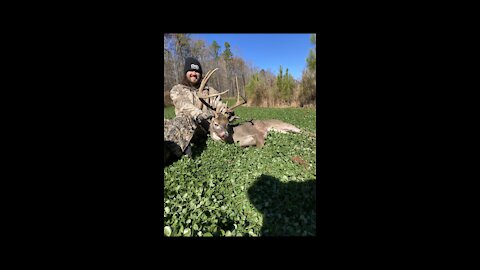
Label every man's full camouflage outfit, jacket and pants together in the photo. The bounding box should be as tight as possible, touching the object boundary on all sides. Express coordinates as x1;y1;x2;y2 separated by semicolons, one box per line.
163;84;227;157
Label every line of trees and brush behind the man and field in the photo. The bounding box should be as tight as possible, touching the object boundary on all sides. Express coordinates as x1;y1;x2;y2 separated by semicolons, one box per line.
163;33;316;107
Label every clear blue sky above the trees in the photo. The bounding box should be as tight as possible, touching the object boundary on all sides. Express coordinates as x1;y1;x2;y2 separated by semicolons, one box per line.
191;34;315;80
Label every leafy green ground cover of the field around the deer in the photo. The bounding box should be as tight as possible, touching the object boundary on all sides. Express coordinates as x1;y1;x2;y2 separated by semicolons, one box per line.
164;105;316;236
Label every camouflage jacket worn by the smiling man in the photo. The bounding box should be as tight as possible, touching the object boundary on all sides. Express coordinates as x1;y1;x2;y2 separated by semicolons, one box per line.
170;84;223;120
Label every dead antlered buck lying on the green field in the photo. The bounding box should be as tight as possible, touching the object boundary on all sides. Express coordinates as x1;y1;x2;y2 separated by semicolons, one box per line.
199;69;301;148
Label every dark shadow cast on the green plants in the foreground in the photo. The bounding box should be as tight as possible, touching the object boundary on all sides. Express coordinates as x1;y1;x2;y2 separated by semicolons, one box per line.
248;175;316;236
